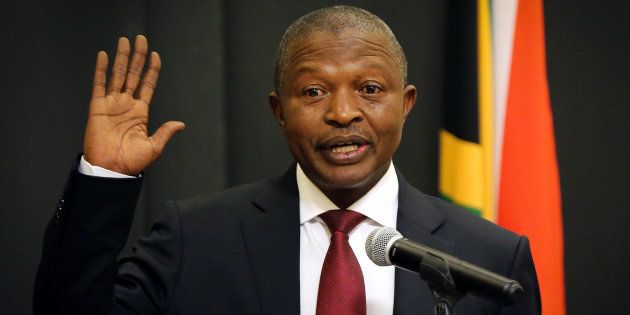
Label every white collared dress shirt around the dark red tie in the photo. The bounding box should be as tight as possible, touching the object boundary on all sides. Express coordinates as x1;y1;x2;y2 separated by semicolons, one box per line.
296;164;398;315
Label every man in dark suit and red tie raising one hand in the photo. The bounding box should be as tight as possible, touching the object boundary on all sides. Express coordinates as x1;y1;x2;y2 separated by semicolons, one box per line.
34;6;540;314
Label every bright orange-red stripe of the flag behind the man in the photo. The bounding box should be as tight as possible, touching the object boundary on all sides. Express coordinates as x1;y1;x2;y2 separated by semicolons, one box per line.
498;0;565;315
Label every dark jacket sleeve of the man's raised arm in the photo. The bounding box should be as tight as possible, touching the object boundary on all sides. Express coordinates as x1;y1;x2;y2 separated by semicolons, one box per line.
33;170;180;314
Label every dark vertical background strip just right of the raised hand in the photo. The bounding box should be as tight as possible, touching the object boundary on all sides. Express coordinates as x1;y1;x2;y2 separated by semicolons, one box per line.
142;0;227;230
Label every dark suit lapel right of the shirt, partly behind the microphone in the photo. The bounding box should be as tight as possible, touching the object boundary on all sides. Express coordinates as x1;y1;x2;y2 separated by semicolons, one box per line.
394;172;453;314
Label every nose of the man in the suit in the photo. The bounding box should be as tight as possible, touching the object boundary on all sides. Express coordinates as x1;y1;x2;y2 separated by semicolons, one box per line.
325;91;363;128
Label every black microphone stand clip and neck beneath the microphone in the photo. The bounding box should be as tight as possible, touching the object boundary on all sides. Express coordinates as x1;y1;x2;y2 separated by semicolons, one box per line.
419;253;466;315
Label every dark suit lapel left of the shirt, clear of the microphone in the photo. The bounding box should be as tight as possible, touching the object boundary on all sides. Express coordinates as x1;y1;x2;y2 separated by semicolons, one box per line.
242;167;300;314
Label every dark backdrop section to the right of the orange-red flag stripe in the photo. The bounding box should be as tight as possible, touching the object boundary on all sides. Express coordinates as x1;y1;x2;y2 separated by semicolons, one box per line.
545;1;630;314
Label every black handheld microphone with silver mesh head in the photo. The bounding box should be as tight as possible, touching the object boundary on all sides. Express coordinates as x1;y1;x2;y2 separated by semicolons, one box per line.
365;227;523;305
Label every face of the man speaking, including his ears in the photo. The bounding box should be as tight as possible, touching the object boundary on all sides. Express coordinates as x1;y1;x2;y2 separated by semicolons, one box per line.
269;29;416;201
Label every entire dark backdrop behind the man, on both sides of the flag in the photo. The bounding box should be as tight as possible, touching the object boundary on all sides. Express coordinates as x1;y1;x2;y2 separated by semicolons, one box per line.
0;0;630;314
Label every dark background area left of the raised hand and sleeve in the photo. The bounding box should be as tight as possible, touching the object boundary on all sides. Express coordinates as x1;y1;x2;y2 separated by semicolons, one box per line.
0;1;149;314
